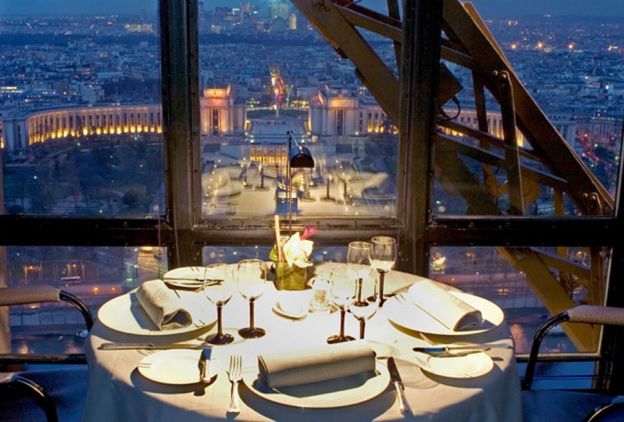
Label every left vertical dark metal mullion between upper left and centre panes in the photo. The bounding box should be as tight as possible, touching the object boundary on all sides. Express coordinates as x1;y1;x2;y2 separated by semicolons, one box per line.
160;0;201;268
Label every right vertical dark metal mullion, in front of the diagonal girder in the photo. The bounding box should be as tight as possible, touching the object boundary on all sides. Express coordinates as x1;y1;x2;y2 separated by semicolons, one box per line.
397;0;442;275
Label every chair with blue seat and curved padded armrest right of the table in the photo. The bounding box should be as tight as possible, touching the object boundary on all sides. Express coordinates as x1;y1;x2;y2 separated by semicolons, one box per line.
522;305;624;422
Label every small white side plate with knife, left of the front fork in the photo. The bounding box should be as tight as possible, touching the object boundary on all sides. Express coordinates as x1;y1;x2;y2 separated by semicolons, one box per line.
137;349;215;385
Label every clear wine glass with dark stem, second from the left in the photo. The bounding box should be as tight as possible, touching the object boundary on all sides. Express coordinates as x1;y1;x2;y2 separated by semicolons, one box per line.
236;259;267;338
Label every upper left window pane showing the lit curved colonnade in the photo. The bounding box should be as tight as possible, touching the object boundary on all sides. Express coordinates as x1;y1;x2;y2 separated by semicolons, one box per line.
0;4;164;217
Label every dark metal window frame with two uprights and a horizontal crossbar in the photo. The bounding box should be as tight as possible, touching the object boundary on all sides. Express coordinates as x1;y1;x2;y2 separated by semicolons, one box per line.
0;0;624;388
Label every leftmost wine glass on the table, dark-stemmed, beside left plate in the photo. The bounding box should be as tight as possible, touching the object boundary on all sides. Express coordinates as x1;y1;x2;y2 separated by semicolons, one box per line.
203;264;234;344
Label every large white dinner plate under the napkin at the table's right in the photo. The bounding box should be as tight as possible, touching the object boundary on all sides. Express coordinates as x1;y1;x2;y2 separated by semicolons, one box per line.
383;291;505;336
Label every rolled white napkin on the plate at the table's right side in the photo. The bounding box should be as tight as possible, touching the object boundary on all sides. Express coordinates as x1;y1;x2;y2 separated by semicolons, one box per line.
408;280;483;331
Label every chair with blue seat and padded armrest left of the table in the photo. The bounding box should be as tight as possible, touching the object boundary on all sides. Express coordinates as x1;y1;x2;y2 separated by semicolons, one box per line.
0;285;93;421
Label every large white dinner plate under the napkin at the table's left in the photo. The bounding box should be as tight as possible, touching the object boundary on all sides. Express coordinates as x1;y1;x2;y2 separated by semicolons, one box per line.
98;289;216;336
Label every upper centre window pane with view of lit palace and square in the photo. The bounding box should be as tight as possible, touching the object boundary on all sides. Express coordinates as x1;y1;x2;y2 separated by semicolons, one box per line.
200;1;398;218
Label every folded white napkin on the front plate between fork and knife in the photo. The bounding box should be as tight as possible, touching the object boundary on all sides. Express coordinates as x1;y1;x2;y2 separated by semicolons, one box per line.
258;341;375;388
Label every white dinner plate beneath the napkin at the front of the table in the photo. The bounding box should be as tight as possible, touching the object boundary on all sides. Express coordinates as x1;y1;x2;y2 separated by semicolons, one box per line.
243;362;390;409
